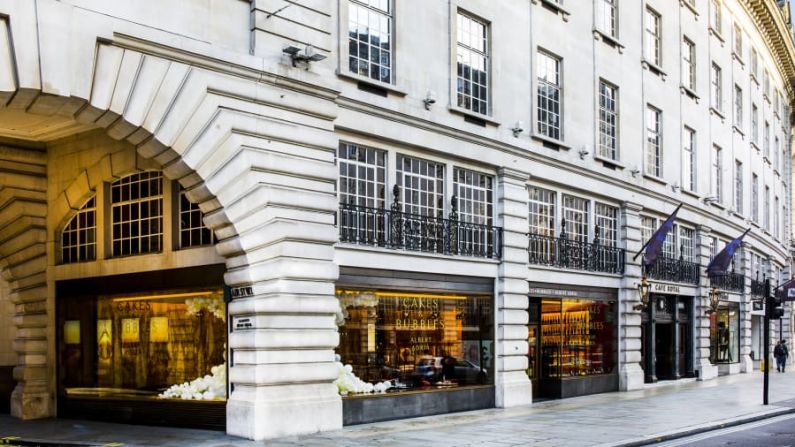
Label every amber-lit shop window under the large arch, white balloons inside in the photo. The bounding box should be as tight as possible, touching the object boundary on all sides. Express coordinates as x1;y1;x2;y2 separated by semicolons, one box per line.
58;289;227;401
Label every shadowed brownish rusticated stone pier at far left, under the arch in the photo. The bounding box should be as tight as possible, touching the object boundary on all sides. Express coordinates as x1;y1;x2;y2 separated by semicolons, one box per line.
0;147;54;419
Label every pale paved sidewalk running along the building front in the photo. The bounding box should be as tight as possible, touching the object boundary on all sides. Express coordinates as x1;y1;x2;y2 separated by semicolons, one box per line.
0;372;795;447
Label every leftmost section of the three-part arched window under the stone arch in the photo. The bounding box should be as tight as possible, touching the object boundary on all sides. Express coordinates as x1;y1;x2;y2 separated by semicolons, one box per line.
61;197;97;264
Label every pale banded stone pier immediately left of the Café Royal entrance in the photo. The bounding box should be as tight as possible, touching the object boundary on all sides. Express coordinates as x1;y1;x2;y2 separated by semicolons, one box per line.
618;202;644;391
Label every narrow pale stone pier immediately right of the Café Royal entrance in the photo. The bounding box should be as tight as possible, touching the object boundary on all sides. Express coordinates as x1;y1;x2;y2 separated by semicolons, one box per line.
693;225;718;380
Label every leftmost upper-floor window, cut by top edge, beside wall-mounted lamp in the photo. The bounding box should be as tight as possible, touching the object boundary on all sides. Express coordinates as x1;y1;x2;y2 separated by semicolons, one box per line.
348;0;393;84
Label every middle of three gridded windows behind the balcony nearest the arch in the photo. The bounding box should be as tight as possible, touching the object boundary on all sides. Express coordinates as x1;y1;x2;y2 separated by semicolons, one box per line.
397;155;444;217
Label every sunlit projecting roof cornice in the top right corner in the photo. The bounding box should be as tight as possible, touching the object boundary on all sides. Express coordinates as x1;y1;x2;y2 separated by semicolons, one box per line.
739;0;795;103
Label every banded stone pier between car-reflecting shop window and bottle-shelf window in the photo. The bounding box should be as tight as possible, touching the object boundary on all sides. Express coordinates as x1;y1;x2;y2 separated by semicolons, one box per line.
494;168;533;408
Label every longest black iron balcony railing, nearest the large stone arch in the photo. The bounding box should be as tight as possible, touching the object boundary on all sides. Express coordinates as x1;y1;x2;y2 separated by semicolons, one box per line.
338;203;502;259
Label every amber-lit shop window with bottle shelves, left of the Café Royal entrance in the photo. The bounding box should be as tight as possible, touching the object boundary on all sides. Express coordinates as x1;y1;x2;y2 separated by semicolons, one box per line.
529;299;616;379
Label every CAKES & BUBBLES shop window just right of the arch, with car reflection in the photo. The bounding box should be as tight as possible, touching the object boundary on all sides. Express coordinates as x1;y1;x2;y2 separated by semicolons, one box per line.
337;290;494;394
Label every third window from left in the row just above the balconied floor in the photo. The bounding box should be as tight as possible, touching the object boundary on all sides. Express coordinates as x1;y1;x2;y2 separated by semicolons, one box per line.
537;51;563;140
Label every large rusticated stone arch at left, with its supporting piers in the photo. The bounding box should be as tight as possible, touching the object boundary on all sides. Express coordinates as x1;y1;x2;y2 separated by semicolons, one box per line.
0;0;342;439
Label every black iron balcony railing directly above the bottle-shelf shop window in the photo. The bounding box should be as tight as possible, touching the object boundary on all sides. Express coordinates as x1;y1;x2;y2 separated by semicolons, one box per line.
527;233;626;274
